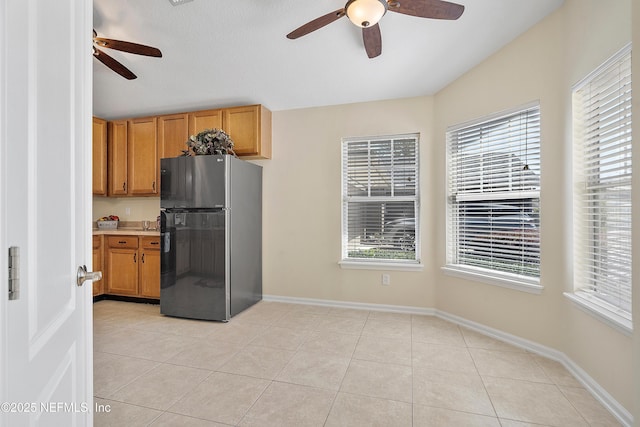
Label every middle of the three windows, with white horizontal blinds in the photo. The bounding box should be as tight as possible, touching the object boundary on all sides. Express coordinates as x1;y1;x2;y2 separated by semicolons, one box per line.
445;103;540;291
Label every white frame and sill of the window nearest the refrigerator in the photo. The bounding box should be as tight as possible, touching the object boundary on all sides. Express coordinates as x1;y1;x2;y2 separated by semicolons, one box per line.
338;132;424;270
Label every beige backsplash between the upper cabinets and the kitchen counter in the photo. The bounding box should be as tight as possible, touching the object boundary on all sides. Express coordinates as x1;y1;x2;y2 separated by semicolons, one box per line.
91;196;160;222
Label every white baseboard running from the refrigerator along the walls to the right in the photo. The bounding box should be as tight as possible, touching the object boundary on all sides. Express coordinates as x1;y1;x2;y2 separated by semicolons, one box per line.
263;295;633;427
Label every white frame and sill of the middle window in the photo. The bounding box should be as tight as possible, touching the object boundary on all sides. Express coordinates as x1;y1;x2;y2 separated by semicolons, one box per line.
441;101;544;294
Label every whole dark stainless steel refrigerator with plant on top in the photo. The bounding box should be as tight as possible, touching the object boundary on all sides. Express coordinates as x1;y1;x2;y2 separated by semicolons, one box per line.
160;155;262;321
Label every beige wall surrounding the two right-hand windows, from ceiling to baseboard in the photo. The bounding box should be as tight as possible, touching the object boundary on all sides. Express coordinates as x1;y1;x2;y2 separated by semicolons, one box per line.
432;0;633;410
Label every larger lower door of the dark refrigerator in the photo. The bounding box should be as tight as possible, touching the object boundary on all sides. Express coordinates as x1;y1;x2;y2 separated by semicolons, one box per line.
160;210;230;320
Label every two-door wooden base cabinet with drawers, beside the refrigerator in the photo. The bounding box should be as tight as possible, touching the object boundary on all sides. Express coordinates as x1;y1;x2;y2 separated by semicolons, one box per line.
102;235;160;299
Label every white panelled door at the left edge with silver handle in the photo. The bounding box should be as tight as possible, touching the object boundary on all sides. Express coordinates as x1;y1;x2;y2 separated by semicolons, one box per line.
0;0;93;427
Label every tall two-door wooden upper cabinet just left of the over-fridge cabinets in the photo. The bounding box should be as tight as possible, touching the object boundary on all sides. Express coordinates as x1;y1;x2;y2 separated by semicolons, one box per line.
108;117;159;196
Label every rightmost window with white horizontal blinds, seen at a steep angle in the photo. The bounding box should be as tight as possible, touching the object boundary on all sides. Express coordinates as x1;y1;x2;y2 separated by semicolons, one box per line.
573;46;632;328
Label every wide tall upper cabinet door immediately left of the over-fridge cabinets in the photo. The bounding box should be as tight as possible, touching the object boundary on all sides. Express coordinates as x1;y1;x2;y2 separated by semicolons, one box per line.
127;117;158;196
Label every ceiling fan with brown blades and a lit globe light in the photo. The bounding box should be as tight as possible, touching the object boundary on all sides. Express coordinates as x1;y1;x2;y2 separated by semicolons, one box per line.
287;0;464;58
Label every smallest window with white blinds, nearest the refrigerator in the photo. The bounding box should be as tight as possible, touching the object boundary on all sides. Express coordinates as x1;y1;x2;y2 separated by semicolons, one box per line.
342;134;420;264
